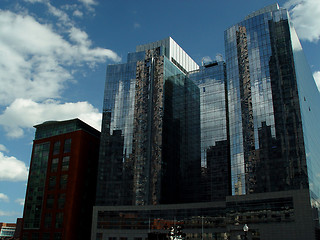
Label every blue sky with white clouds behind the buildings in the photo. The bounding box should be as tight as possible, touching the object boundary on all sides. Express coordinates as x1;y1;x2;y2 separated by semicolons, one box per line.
0;0;320;222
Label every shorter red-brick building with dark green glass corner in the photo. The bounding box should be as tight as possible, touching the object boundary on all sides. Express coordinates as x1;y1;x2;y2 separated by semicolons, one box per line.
21;119;100;240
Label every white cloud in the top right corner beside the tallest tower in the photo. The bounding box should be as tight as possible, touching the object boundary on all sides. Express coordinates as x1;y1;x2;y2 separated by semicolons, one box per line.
284;0;320;42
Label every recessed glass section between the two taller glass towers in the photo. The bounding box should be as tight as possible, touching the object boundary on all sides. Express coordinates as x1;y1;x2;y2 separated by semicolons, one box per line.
189;62;231;201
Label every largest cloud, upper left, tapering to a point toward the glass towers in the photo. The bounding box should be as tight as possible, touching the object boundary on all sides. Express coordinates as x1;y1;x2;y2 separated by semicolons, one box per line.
0;7;120;105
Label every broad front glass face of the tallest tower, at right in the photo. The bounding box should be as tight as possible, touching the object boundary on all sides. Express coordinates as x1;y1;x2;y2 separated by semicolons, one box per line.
225;5;308;195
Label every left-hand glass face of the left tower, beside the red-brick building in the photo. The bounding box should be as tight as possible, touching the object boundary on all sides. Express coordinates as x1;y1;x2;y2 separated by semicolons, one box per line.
96;53;144;205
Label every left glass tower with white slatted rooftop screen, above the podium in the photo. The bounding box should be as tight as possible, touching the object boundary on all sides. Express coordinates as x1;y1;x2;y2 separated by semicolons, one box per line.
96;38;201;206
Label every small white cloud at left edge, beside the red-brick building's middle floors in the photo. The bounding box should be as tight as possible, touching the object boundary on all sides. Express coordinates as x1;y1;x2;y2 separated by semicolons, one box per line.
0;152;28;182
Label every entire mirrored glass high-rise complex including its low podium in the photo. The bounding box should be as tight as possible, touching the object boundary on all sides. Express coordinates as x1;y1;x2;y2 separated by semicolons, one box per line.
91;4;320;240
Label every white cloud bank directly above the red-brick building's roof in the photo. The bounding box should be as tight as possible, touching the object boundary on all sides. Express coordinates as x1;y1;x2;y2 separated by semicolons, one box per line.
0;99;102;138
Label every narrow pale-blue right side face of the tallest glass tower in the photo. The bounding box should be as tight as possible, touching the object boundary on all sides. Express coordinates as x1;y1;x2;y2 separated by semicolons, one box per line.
290;16;320;222
